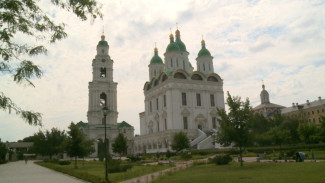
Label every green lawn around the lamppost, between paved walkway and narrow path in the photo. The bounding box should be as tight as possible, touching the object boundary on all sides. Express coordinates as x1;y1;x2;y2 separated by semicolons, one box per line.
37;161;170;183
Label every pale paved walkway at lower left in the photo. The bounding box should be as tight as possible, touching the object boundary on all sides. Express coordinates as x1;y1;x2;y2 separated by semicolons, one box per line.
0;161;85;183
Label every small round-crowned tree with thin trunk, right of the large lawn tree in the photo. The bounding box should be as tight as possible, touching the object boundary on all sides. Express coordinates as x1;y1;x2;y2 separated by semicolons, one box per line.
267;127;290;152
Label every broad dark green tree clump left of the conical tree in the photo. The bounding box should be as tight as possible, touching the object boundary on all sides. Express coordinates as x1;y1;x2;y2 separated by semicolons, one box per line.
31;128;66;159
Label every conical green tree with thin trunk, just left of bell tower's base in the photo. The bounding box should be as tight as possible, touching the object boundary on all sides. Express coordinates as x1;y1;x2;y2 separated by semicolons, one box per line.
66;122;94;168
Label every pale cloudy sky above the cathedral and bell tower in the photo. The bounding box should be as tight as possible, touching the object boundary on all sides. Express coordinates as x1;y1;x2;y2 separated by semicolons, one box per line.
0;0;325;141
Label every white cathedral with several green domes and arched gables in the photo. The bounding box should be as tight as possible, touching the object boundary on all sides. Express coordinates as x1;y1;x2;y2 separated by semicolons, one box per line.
133;29;225;153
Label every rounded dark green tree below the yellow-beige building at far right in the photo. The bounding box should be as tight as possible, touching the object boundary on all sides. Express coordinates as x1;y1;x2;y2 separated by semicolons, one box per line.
298;123;319;144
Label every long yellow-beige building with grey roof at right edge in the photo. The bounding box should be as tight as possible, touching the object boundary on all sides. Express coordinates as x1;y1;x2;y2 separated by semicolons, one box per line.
281;97;325;124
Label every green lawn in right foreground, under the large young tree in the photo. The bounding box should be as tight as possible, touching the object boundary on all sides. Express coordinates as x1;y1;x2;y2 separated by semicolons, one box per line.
154;162;325;183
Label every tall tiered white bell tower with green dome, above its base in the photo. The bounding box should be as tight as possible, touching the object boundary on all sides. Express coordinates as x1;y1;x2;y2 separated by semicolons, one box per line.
87;35;118;127
